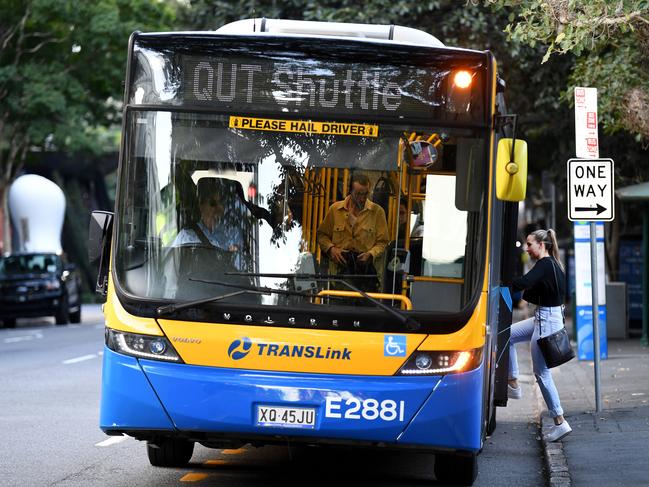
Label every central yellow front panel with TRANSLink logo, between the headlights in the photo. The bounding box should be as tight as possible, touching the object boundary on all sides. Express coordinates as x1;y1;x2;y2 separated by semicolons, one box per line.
160;320;426;375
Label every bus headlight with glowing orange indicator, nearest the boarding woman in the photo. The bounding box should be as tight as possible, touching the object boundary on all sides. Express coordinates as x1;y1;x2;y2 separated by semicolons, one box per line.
397;348;482;375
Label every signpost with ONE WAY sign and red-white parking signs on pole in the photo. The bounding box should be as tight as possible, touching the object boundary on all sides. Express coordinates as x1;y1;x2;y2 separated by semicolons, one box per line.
568;87;615;412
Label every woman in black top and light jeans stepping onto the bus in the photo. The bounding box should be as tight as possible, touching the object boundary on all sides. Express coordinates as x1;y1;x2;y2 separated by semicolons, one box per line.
507;229;572;441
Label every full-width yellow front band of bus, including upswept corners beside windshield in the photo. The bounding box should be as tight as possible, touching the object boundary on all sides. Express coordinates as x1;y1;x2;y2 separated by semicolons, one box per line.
104;283;487;376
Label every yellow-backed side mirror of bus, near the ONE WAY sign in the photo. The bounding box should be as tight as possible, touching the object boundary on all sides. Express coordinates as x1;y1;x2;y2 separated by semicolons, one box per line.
496;139;527;201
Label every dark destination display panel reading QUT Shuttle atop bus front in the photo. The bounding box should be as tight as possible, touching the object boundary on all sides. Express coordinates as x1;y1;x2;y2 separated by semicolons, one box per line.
130;37;487;122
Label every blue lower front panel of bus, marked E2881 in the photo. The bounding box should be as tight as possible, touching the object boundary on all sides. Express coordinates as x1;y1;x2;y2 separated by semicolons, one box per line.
101;350;482;452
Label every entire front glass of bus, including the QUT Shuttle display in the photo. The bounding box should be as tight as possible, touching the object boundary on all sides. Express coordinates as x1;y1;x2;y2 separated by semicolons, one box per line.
114;38;490;328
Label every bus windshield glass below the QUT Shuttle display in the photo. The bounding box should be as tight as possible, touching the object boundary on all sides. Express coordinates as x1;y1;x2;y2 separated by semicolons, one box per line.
117;111;484;311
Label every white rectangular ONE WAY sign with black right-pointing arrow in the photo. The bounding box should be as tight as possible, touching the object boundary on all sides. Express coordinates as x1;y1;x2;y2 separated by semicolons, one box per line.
568;159;615;222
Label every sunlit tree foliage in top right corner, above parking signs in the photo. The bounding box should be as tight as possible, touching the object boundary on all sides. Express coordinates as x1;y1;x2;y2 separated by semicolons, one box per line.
476;0;649;144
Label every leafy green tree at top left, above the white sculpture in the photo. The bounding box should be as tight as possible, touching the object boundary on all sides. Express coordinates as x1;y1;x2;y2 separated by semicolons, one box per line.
0;0;174;249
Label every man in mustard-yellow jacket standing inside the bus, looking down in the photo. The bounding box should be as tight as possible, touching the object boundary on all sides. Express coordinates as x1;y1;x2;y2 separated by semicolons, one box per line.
317;174;388;292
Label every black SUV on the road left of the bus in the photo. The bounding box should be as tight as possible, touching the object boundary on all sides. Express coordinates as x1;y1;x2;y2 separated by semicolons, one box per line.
0;253;81;328
